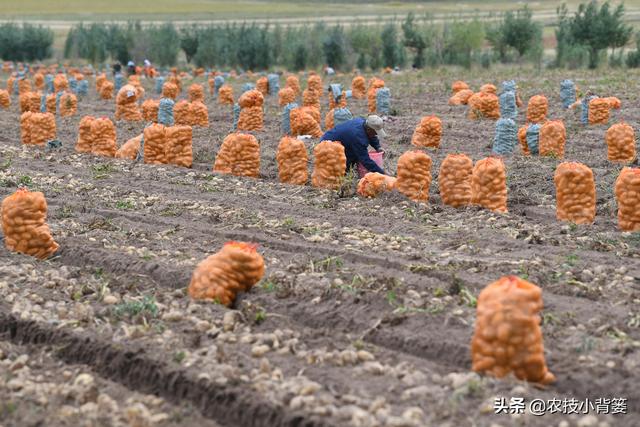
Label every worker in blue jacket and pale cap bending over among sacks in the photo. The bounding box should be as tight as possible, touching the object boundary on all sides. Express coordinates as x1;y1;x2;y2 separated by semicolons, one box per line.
321;115;387;174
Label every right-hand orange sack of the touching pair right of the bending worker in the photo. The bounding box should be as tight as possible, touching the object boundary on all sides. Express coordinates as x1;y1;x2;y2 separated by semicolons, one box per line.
471;157;507;212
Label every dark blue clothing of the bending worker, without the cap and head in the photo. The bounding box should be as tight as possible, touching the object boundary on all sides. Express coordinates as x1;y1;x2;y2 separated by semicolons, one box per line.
321;117;384;174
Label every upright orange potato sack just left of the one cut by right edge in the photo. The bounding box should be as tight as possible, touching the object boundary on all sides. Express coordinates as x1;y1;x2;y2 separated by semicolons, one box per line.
553;162;596;224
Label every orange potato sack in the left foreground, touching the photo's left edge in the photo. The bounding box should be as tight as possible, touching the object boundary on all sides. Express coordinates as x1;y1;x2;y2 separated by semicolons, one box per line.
1;188;59;259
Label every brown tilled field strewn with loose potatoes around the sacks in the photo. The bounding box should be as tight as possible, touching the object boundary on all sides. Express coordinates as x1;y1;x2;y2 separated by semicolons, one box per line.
0;71;640;427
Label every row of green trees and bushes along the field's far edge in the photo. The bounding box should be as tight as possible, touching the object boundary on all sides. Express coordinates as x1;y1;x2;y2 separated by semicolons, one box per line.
0;0;640;70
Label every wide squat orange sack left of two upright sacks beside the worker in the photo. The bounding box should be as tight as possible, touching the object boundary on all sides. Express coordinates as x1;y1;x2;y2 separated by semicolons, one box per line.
213;133;260;178
